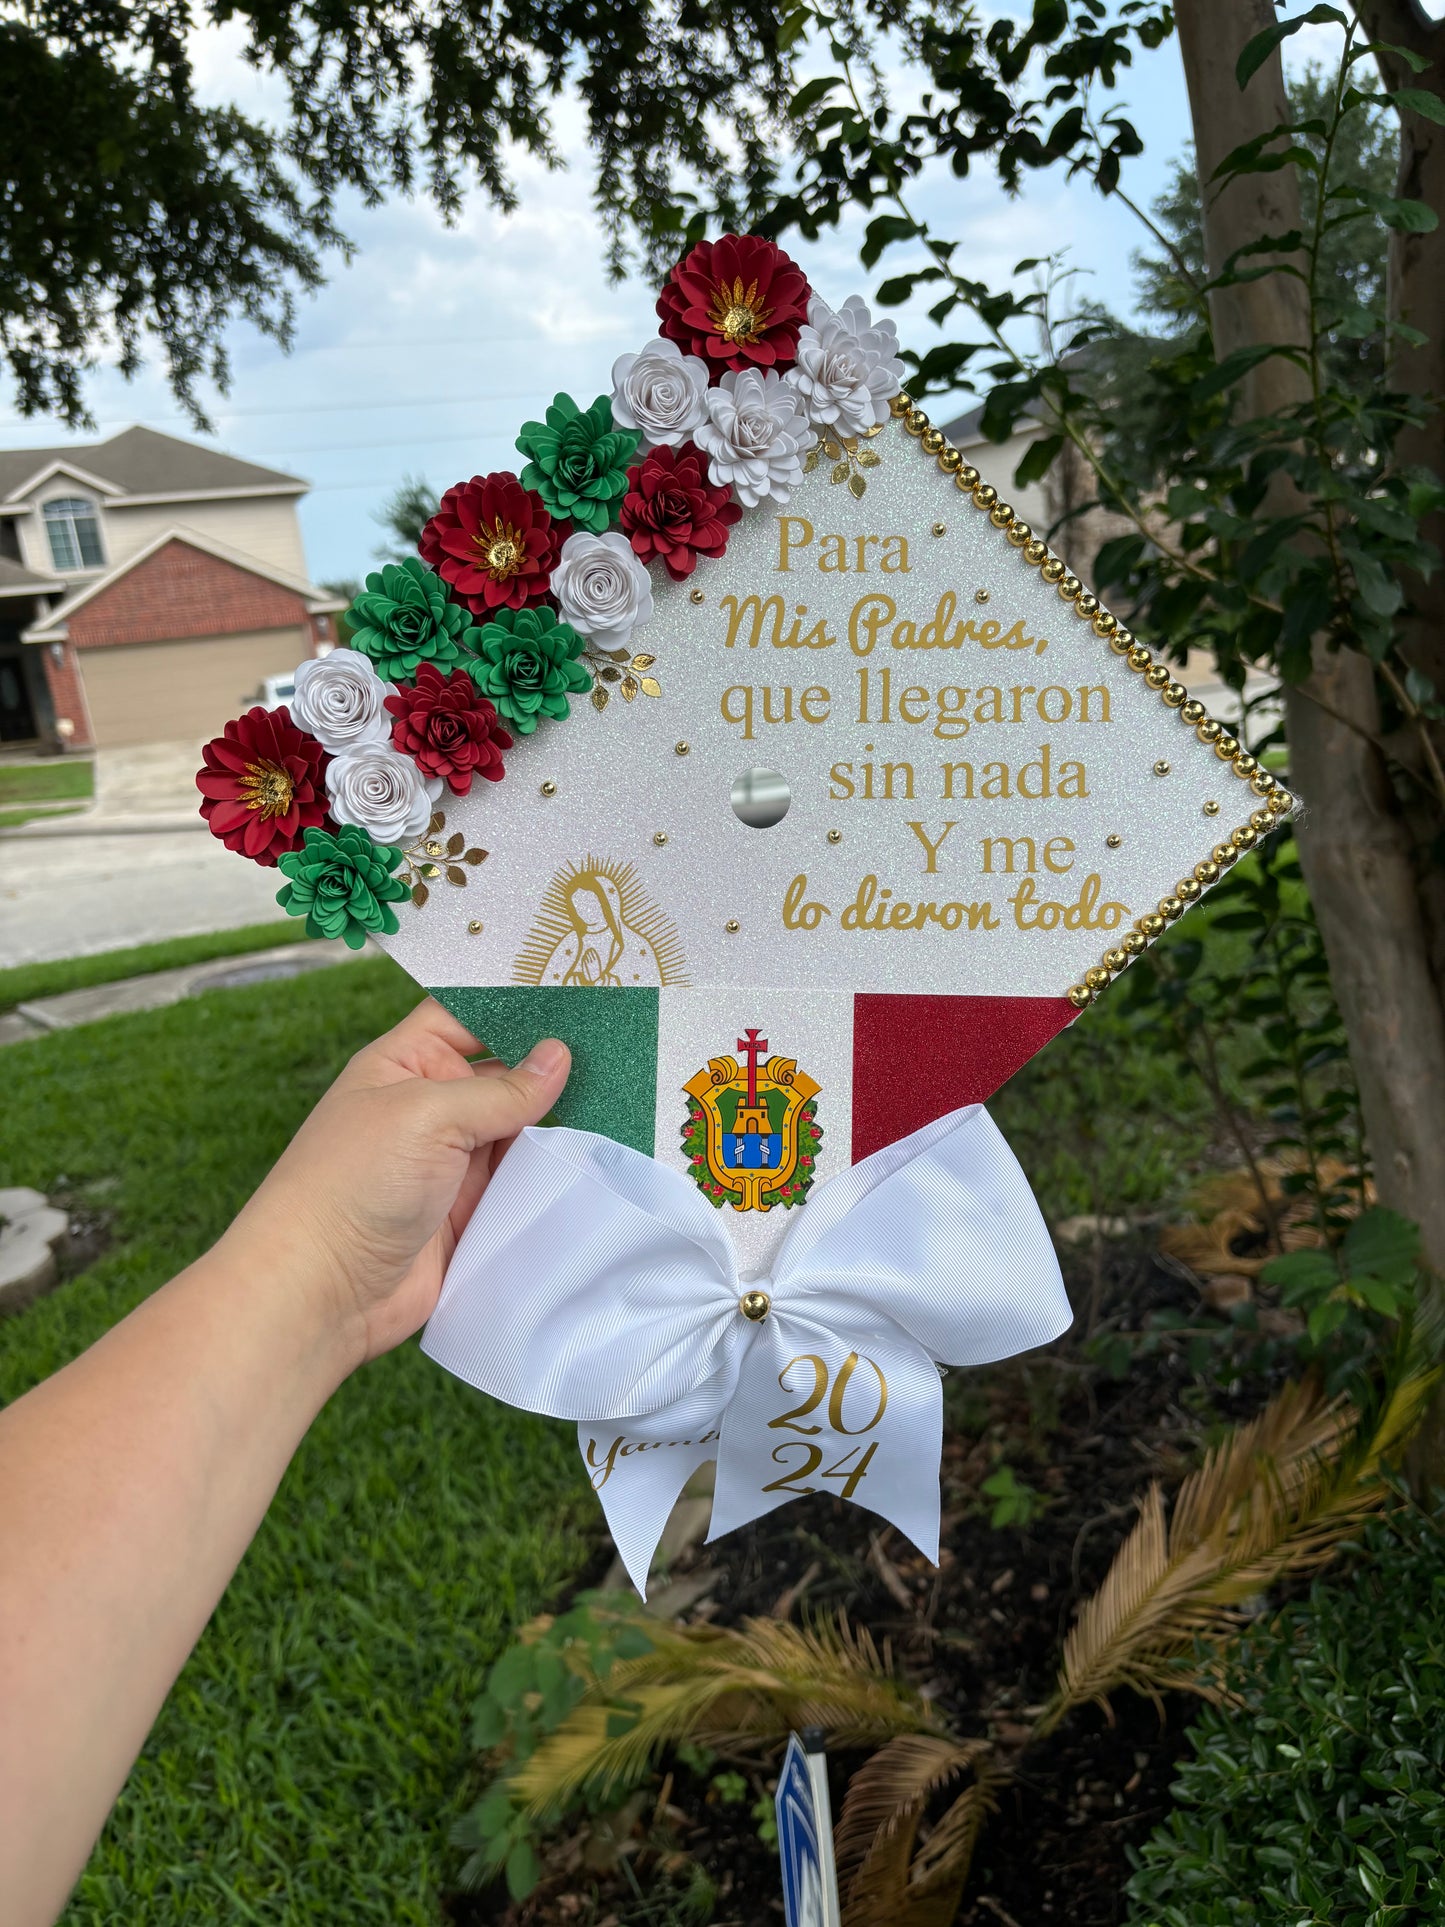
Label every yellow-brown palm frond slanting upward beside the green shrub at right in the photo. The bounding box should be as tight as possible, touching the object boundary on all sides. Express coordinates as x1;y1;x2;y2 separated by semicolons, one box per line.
1038;1372;1435;1732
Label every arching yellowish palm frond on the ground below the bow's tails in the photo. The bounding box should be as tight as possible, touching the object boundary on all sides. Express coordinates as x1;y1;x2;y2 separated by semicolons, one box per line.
512;1619;938;1819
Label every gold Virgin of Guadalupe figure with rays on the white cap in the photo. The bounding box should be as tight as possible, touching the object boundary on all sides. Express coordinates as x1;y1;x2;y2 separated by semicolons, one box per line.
512;856;688;989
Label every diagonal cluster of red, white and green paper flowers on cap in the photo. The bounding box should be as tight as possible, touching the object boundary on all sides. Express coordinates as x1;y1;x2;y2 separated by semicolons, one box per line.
197;235;902;928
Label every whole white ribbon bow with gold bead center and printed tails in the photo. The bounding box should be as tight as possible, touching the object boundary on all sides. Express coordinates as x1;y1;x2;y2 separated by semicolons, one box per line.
422;1104;1071;1594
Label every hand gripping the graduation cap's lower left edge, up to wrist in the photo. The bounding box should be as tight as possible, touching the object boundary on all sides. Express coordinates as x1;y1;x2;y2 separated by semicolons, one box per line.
222;998;572;1372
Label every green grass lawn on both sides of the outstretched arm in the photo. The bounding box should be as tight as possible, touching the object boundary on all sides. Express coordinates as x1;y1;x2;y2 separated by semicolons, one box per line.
0;955;597;1927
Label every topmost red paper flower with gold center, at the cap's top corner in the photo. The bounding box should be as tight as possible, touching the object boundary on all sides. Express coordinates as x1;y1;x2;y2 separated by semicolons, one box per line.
657;235;809;380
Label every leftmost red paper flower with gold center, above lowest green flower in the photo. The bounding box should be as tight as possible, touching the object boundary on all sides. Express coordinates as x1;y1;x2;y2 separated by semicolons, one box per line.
197;709;329;867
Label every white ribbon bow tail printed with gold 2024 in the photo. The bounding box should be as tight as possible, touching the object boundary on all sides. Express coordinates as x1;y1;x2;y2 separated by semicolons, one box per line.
707;1303;944;1563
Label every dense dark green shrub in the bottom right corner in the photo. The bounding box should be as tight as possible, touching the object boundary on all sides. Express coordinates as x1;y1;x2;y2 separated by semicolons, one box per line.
1129;1513;1445;1927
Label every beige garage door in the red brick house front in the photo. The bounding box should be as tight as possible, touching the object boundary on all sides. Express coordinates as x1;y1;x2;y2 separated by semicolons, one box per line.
77;628;310;750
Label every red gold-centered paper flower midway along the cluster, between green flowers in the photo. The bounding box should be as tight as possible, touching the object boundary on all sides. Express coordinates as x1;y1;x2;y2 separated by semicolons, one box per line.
416;470;566;615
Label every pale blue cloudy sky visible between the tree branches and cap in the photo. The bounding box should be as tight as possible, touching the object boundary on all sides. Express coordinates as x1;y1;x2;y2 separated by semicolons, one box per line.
0;0;1371;582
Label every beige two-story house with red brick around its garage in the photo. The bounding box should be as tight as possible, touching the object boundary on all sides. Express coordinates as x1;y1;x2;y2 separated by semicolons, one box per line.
0;428;345;750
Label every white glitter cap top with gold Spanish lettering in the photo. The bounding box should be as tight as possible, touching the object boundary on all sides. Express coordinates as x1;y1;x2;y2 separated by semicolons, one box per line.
381;420;1256;1002
